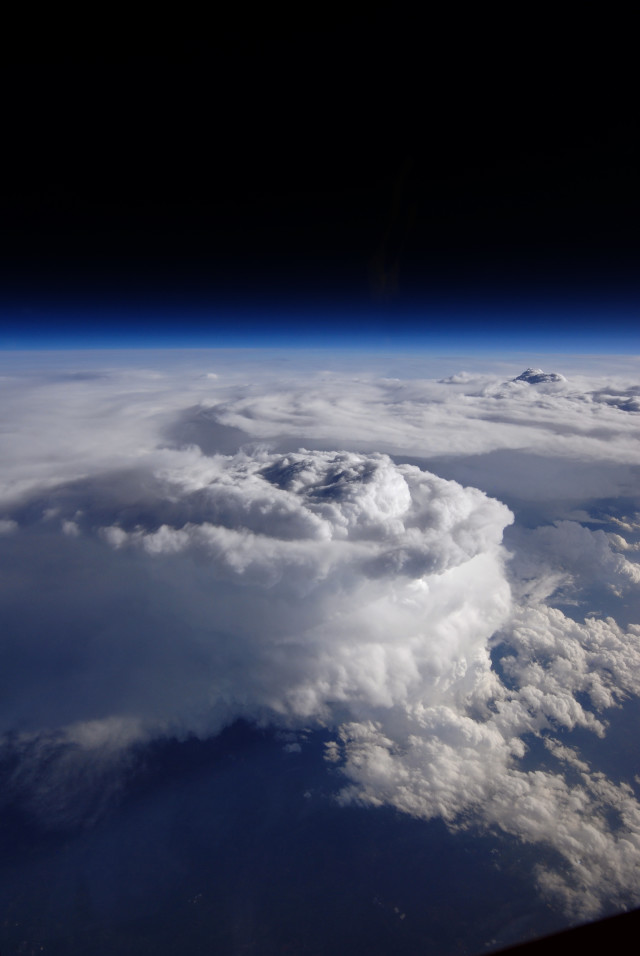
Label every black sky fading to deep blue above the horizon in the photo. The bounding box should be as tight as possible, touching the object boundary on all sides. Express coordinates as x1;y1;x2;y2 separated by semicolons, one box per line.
0;11;640;344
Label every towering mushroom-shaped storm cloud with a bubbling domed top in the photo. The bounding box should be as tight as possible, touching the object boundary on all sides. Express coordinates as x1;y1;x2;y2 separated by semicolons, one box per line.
0;451;511;732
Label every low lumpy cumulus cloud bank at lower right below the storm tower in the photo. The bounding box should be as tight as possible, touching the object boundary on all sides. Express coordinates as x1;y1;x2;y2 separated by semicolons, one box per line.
327;606;640;918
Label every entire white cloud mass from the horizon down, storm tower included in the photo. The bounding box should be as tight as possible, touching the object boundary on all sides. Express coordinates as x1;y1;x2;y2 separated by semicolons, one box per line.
0;356;640;916
